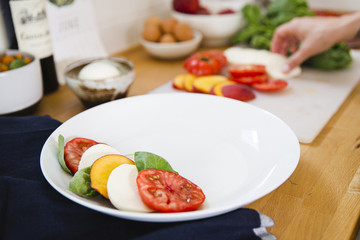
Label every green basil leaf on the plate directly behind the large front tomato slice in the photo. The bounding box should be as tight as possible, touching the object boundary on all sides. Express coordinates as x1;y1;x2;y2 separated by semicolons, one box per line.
135;152;178;174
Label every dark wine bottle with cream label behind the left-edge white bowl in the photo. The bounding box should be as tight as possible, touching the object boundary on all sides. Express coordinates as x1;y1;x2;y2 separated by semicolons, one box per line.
8;0;59;94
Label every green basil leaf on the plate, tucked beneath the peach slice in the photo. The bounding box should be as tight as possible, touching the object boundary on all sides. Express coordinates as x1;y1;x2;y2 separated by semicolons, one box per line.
69;167;99;197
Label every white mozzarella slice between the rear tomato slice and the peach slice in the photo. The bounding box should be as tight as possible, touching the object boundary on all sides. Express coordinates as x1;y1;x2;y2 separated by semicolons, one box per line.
78;143;120;170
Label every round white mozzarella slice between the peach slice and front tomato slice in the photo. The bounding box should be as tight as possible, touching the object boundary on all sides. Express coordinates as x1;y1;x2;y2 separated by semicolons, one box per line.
107;164;153;212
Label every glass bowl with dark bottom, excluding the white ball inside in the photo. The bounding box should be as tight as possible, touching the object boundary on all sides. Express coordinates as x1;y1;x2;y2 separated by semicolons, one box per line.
65;57;135;107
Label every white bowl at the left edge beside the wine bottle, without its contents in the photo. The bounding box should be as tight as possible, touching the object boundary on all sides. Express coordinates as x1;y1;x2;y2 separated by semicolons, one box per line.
0;50;43;115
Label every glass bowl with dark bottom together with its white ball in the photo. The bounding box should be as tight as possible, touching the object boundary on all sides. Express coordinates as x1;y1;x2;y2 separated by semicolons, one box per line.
65;57;135;107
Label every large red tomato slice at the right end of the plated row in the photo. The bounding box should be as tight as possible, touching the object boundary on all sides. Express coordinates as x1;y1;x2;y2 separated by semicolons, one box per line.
136;169;205;212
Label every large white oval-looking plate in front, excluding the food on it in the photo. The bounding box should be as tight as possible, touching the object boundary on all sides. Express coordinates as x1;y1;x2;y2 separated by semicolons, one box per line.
40;93;300;222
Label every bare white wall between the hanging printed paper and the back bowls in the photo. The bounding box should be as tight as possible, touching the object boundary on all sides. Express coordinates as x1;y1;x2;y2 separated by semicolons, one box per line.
92;0;171;54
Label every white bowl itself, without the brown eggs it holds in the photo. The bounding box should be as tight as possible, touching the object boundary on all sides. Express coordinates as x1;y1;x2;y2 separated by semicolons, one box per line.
140;30;202;59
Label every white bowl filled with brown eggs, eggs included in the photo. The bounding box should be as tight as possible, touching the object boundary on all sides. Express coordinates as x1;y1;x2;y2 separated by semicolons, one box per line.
140;17;202;59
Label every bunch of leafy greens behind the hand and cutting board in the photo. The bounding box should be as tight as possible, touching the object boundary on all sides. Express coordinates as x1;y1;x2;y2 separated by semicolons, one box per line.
232;0;352;70
